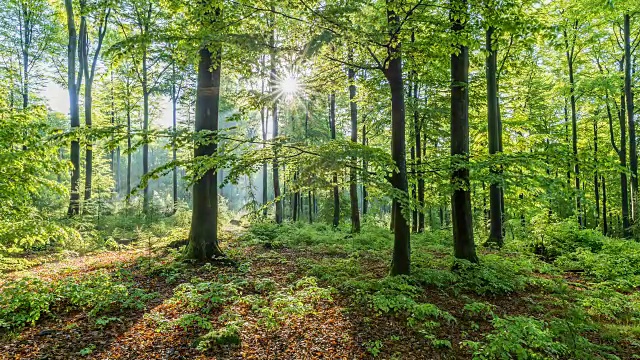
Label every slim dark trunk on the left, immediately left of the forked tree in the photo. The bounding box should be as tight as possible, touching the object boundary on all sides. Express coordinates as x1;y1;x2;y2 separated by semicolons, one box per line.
64;0;80;216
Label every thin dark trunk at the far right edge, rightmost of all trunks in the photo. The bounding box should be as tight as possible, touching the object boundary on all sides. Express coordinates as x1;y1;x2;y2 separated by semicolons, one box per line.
620;13;638;222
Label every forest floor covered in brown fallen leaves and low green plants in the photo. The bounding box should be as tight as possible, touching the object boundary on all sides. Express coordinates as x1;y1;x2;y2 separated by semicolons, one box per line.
0;221;640;359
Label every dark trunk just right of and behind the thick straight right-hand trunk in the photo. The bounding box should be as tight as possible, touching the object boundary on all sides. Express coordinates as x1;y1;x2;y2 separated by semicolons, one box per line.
486;26;504;247
